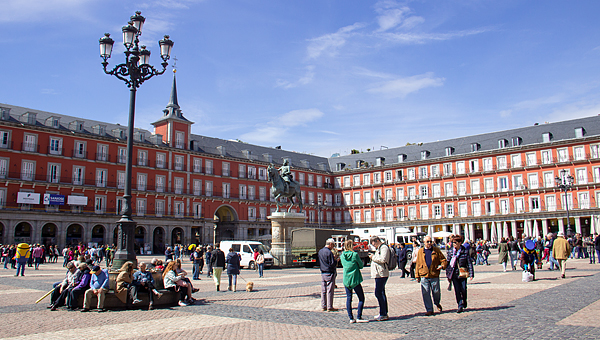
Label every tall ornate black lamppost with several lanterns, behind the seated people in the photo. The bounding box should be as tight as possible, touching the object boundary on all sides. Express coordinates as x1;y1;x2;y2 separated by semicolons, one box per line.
100;11;173;268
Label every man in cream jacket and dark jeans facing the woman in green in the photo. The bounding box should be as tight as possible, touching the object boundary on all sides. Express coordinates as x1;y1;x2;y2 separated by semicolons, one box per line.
369;236;390;321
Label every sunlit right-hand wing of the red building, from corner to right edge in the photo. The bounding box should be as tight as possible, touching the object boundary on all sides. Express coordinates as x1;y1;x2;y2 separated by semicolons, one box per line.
330;117;600;240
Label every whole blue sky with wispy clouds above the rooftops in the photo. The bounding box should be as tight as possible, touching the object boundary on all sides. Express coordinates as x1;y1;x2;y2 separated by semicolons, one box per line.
0;0;600;157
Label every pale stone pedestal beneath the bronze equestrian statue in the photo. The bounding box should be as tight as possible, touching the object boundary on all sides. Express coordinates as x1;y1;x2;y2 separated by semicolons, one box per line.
267;212;306;267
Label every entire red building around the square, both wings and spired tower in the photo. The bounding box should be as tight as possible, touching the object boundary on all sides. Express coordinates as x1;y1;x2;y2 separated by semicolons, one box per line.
0;76;600;253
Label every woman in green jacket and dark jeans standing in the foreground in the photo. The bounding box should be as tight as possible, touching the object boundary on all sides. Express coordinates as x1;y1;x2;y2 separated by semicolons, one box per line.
340;240;369;323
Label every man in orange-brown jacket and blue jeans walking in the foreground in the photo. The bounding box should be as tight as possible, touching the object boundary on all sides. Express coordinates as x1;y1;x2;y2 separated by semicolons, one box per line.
415;236;448;316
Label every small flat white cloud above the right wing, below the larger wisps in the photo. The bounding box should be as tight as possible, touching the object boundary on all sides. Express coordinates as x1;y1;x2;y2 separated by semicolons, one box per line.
367;72;445;98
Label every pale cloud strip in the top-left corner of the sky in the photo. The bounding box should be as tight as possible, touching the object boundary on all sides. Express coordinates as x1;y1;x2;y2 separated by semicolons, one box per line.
0;0;92;24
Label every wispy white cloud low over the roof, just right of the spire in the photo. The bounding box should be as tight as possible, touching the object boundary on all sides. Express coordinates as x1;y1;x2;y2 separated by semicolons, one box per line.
240;109;323;143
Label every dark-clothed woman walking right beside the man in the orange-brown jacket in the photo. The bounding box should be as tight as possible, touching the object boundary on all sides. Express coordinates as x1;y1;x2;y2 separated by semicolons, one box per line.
446;235;474;313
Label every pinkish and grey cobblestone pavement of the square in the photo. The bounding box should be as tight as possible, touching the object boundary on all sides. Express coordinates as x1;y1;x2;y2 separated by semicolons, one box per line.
0;257;600;340
